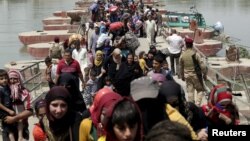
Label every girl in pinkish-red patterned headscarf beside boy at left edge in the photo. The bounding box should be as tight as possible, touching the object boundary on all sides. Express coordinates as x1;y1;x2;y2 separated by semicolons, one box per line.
8;70;29;141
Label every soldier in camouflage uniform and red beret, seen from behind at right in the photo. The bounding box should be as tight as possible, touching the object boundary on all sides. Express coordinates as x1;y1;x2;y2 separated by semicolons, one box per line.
179;37;206;106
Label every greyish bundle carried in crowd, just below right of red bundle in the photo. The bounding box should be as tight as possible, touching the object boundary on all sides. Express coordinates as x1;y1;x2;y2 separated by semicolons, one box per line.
124;31;140;51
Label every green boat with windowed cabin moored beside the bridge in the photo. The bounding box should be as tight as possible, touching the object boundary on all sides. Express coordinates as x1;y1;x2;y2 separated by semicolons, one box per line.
164;11;206;28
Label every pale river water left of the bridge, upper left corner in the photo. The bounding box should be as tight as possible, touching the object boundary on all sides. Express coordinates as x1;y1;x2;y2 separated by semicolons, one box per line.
0;0;77;66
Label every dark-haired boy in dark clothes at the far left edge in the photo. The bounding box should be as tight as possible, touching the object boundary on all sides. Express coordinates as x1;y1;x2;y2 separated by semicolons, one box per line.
0;69;16;141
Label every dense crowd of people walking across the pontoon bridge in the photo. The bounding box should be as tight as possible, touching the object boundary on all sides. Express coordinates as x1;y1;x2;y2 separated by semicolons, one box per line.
0;0;239;141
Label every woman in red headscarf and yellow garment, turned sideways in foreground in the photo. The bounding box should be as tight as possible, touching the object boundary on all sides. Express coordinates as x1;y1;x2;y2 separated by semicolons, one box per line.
79;88;121;141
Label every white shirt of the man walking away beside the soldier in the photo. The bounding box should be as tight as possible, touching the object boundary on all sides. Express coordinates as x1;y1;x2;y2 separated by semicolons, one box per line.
166;34;184;54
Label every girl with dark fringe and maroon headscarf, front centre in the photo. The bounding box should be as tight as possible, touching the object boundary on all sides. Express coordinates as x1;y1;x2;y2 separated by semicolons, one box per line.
102;97;143;141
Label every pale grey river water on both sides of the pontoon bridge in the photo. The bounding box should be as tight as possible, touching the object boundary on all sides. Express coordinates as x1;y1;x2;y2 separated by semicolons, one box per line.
0;0;250;67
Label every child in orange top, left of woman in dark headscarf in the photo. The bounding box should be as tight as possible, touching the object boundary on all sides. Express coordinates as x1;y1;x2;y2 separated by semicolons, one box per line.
33;99;47;141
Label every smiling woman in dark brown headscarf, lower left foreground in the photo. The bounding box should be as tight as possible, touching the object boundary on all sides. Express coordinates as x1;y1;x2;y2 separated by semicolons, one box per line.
36;86;82;141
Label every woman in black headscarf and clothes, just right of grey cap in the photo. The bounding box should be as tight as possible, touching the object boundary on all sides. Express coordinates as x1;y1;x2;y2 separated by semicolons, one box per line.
159;80;207;140
